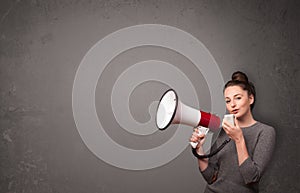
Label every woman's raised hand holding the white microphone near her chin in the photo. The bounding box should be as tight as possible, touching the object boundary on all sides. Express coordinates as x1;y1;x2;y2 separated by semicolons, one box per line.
222;118;244;142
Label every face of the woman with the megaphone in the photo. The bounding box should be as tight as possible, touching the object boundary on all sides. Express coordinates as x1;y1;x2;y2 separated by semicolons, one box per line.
224;86;254;118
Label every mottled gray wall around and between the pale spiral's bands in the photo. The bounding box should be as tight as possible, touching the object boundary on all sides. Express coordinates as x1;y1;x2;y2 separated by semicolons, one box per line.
0;0;300;193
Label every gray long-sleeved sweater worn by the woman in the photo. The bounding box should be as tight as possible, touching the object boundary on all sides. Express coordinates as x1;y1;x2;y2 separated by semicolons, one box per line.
201;122;275;193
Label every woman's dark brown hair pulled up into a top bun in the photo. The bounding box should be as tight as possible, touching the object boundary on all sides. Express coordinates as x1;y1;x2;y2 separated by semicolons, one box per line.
223;71;256;110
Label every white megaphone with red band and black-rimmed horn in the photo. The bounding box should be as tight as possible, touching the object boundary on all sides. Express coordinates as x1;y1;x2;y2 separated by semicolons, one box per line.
156;89;220;148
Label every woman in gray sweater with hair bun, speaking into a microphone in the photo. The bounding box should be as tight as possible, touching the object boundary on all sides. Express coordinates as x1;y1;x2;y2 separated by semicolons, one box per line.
190;71;275;193
